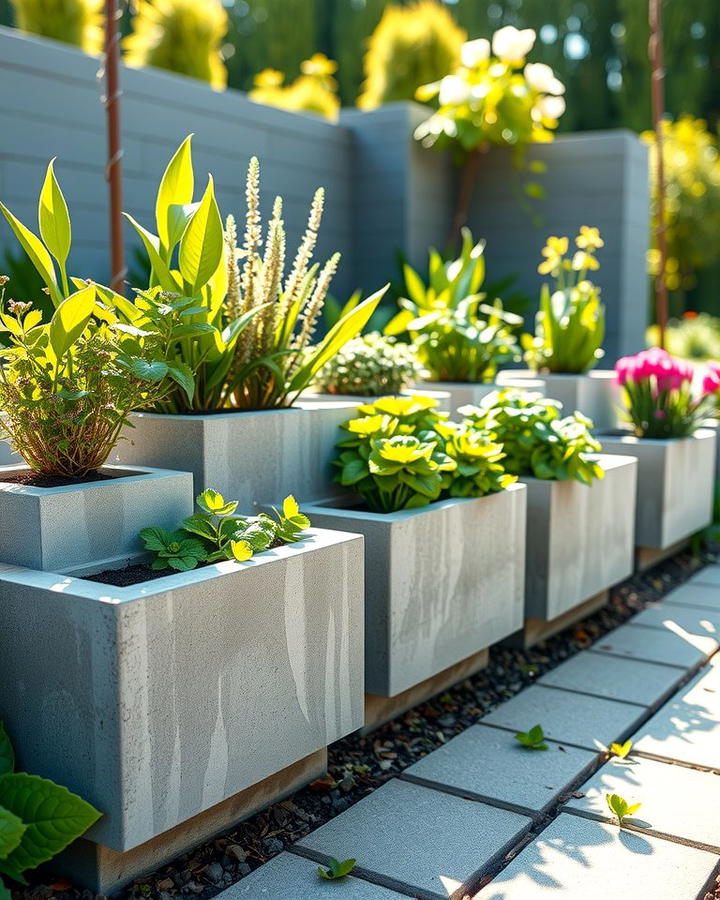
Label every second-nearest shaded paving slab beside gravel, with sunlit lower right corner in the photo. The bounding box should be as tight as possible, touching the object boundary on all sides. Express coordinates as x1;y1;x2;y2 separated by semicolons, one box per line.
299;780;531;898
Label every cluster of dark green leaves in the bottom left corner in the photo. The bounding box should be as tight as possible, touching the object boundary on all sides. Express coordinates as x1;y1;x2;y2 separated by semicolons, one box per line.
0;722;100;898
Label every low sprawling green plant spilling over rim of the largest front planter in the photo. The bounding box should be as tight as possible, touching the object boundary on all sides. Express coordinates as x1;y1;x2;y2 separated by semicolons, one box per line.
140;490;310;572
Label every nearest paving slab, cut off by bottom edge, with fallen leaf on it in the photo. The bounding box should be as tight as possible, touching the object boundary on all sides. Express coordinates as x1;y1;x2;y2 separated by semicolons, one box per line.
218;853;403;900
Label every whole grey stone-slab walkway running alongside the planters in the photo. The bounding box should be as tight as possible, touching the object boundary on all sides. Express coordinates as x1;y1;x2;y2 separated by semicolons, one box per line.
214;566;720;900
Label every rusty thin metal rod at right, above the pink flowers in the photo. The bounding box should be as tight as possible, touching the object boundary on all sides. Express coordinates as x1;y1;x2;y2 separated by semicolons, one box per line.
648;0;669;348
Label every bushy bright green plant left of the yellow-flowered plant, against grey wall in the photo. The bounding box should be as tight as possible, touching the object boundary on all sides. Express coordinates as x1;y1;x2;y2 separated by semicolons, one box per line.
385;228;523;383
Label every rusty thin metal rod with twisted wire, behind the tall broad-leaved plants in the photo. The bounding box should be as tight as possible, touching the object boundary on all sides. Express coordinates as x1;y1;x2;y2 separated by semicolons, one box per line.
105;0;127;294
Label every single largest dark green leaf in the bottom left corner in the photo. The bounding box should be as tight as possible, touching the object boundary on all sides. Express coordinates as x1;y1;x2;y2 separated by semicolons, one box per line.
0;772;100;881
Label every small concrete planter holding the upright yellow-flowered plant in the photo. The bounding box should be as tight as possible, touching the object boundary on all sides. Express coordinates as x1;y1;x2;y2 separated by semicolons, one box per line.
497;369;622;433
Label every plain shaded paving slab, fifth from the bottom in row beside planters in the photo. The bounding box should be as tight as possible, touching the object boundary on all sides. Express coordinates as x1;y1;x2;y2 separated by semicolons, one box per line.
538;650;686;706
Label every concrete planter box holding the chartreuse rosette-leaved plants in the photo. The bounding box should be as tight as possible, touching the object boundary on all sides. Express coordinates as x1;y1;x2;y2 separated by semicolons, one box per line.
303;485;525;697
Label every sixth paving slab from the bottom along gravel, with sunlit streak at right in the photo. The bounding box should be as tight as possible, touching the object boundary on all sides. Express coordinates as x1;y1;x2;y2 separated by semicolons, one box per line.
591;624;720;670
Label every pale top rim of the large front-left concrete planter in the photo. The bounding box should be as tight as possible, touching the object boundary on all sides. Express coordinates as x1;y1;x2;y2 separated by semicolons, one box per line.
0;528;362;606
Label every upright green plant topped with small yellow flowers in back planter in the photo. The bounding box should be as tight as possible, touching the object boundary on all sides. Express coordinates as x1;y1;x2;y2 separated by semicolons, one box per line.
522;232;605;373
